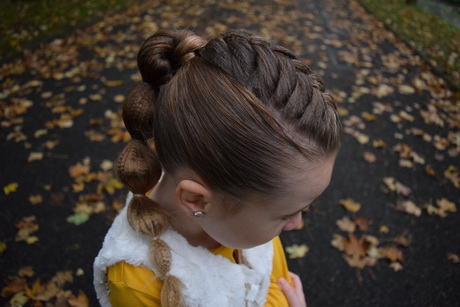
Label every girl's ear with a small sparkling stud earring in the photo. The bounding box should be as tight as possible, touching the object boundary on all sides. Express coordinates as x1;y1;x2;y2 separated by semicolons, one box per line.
176;180;212;215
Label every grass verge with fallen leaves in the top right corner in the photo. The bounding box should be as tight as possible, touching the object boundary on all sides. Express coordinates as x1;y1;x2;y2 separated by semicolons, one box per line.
359;0;460;90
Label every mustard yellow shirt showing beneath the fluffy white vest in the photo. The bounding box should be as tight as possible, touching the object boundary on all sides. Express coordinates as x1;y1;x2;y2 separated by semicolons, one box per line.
107;237;292;307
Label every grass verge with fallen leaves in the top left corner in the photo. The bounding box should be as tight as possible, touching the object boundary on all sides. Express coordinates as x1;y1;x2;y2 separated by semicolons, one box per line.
0;0;134;59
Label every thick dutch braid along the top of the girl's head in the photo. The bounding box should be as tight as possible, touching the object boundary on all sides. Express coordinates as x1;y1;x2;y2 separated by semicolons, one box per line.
201;32;341;153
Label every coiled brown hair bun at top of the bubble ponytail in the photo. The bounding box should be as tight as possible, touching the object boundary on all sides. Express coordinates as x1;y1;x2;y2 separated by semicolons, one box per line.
137;30;206;87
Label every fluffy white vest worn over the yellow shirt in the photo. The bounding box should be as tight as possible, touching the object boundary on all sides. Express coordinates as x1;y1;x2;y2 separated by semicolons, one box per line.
94;193;273;307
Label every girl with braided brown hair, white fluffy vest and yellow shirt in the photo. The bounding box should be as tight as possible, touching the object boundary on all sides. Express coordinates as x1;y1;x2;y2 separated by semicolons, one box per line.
94;31;341;307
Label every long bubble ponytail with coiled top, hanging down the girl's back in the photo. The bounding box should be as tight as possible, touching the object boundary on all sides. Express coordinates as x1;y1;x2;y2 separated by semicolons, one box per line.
117;31;205;306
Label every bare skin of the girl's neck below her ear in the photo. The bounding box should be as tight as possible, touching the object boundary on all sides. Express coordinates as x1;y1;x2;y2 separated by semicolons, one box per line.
149;173;220;249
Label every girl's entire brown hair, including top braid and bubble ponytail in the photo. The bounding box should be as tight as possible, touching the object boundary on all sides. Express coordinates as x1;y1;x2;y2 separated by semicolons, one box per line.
116;30;341;306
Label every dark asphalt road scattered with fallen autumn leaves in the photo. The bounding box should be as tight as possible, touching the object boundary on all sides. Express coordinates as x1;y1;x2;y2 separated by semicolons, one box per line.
0;0;460;307
